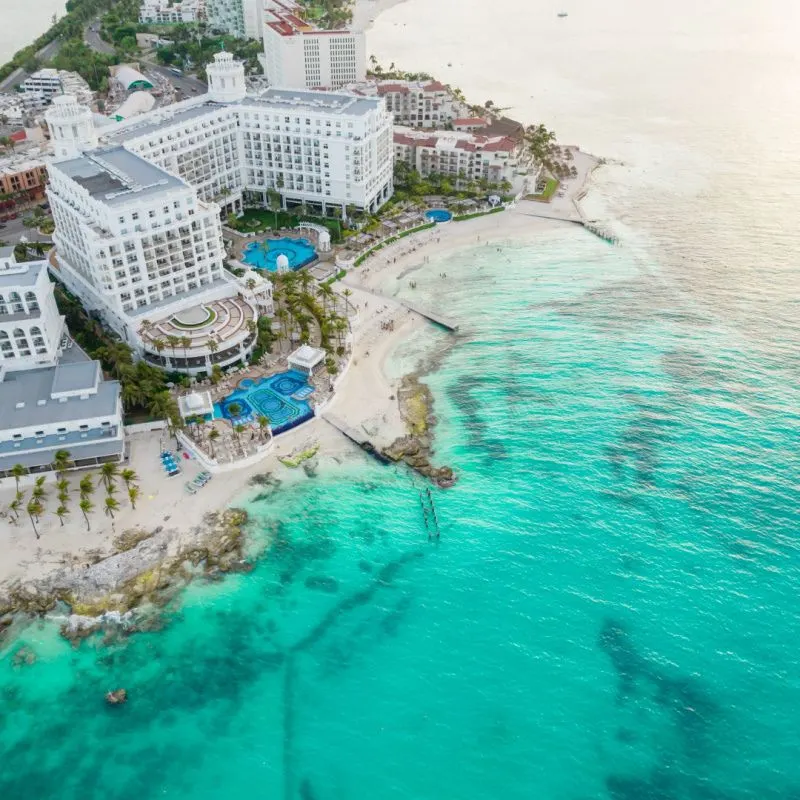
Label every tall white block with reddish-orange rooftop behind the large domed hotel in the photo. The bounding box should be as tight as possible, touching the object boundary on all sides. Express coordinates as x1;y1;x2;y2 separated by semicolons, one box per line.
263;0;366;89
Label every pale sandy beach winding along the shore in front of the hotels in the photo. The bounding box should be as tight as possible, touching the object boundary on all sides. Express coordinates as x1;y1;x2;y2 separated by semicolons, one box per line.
0;0;597;612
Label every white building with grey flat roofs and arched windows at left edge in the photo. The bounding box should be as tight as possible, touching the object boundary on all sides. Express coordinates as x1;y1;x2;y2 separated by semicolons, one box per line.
0;247;125;478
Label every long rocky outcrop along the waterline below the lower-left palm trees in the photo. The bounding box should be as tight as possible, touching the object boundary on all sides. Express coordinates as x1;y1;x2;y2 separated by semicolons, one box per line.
0;509;251;643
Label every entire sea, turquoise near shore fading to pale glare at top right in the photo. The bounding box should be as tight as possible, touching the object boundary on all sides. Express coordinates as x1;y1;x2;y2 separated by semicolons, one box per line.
0;0;800;800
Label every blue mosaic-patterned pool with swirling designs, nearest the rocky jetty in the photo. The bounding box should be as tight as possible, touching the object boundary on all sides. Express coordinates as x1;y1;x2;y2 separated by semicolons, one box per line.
214;370;314;434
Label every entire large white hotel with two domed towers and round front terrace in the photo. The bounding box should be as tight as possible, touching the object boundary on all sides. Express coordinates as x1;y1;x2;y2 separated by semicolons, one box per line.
47;52;393;373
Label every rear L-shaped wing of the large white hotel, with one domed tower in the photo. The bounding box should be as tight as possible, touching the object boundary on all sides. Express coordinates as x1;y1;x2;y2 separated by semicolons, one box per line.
103;53;393;217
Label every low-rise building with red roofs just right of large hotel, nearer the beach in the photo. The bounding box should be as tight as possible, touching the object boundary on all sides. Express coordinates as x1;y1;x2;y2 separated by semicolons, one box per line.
394;126;523;184
